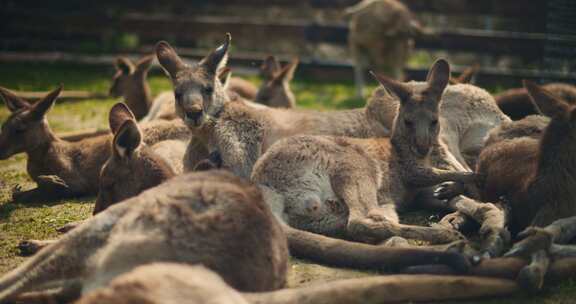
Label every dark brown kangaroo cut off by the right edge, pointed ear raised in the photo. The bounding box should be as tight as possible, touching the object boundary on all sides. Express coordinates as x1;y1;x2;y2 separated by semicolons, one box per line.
440;81;576;288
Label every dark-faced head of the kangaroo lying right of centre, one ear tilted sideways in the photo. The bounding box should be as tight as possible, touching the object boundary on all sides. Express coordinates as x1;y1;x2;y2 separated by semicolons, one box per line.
375;59;450;156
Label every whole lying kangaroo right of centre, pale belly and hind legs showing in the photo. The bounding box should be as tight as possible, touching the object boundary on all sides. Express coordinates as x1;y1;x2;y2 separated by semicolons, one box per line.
252;60;474;243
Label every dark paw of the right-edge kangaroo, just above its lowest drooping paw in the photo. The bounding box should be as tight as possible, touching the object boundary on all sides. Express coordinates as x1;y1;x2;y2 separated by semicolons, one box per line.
504;227;554;257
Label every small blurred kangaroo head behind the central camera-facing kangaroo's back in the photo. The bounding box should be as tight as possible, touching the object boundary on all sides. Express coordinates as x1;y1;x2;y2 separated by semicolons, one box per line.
255;56;298;108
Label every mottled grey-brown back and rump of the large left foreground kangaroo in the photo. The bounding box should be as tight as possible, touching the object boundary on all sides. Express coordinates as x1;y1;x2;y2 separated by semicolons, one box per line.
0;171;288;302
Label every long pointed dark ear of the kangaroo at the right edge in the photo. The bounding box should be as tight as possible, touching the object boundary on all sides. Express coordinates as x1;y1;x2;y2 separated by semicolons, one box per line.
524;80;570;118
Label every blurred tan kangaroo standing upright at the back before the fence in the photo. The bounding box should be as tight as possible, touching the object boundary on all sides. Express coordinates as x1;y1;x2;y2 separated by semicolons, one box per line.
346;0;423;98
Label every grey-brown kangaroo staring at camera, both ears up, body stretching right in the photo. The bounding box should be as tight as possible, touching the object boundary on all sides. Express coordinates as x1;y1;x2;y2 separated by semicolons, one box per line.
156;36;389;177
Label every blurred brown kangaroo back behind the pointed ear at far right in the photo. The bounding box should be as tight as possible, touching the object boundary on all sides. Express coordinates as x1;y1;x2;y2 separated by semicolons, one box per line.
495;83;576;120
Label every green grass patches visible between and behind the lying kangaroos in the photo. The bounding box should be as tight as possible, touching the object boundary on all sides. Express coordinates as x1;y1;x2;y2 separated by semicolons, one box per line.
0;64;576;304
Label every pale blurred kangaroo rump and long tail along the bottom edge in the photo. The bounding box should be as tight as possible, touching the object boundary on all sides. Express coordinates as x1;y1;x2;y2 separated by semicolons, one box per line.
77;263;516;304
